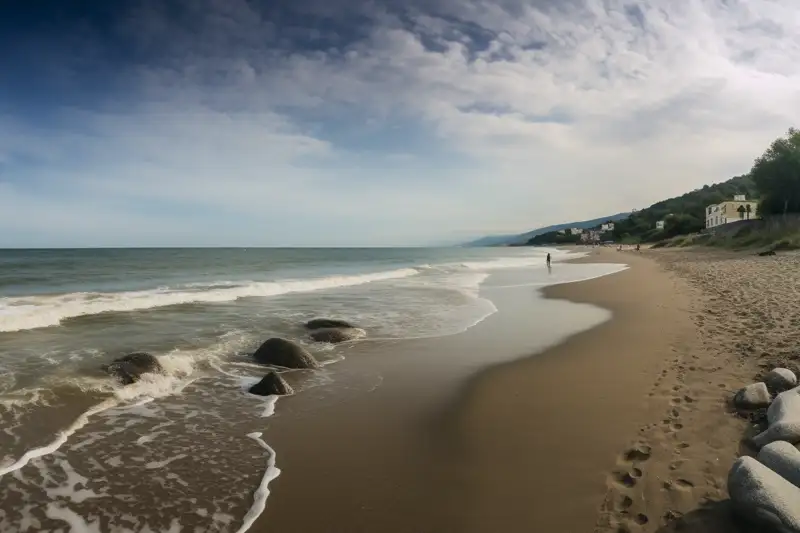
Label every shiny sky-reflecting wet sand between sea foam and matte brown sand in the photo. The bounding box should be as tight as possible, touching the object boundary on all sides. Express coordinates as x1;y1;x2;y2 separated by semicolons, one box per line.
253;256;632;533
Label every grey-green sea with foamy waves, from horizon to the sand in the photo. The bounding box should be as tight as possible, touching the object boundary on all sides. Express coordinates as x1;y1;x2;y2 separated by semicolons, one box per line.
0;248;618;533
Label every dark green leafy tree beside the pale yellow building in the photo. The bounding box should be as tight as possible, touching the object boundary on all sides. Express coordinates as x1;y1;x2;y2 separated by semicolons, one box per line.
750;128;800;215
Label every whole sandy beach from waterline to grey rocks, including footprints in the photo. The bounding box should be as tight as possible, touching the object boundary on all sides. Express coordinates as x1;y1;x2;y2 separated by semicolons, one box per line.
254;248;800;533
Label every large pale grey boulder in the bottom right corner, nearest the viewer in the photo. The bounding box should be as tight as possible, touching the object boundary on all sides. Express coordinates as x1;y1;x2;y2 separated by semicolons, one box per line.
728;457;800;533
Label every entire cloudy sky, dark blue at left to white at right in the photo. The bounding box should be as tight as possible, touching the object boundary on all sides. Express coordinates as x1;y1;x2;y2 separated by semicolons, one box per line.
0;0;800;247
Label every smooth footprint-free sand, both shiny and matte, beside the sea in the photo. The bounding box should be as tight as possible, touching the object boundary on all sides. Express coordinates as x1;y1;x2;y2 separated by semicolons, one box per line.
256;250;697;533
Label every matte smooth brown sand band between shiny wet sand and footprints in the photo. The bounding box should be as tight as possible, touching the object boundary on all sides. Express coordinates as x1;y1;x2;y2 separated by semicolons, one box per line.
444;249;708;532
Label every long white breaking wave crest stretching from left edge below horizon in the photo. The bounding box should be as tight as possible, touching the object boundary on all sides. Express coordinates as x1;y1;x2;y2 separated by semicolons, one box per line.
0;268;420;332
